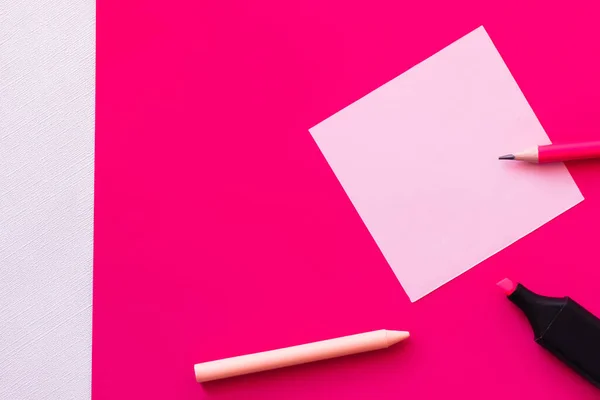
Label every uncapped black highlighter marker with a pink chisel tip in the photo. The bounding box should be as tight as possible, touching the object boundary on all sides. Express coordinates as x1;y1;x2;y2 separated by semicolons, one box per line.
498;279;600;387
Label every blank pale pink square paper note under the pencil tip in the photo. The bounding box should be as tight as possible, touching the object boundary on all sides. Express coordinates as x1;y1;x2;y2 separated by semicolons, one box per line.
310;27;583;301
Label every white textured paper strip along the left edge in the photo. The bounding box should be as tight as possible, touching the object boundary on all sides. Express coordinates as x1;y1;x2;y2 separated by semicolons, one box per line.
0;0;95;400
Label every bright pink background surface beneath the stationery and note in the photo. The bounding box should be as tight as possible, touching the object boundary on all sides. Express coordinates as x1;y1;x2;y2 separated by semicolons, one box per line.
92;0;600;400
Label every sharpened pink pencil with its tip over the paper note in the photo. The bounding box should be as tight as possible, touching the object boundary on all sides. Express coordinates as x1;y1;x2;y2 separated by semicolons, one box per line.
498;141;600;164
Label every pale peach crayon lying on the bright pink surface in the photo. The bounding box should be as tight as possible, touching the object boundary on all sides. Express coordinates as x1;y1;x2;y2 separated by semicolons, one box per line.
194;329;410;382
